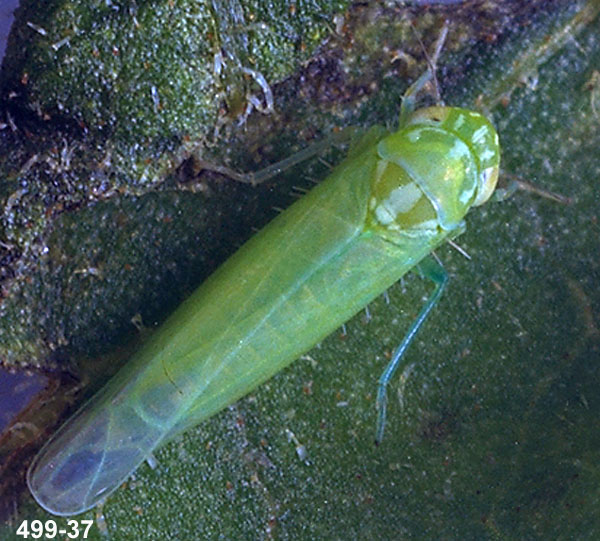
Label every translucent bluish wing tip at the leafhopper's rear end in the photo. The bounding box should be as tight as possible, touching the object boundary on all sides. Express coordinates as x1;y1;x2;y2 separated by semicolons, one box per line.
27;374;164;515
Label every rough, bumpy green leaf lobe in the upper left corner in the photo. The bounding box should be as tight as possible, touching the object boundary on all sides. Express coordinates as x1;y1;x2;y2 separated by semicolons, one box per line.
4;0;347;146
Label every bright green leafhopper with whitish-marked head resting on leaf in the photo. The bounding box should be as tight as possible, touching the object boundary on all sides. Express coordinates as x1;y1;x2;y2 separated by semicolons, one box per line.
27;48;500;515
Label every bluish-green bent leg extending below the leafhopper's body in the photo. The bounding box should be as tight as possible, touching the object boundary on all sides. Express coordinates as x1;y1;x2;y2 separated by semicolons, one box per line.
375;257;448;444
